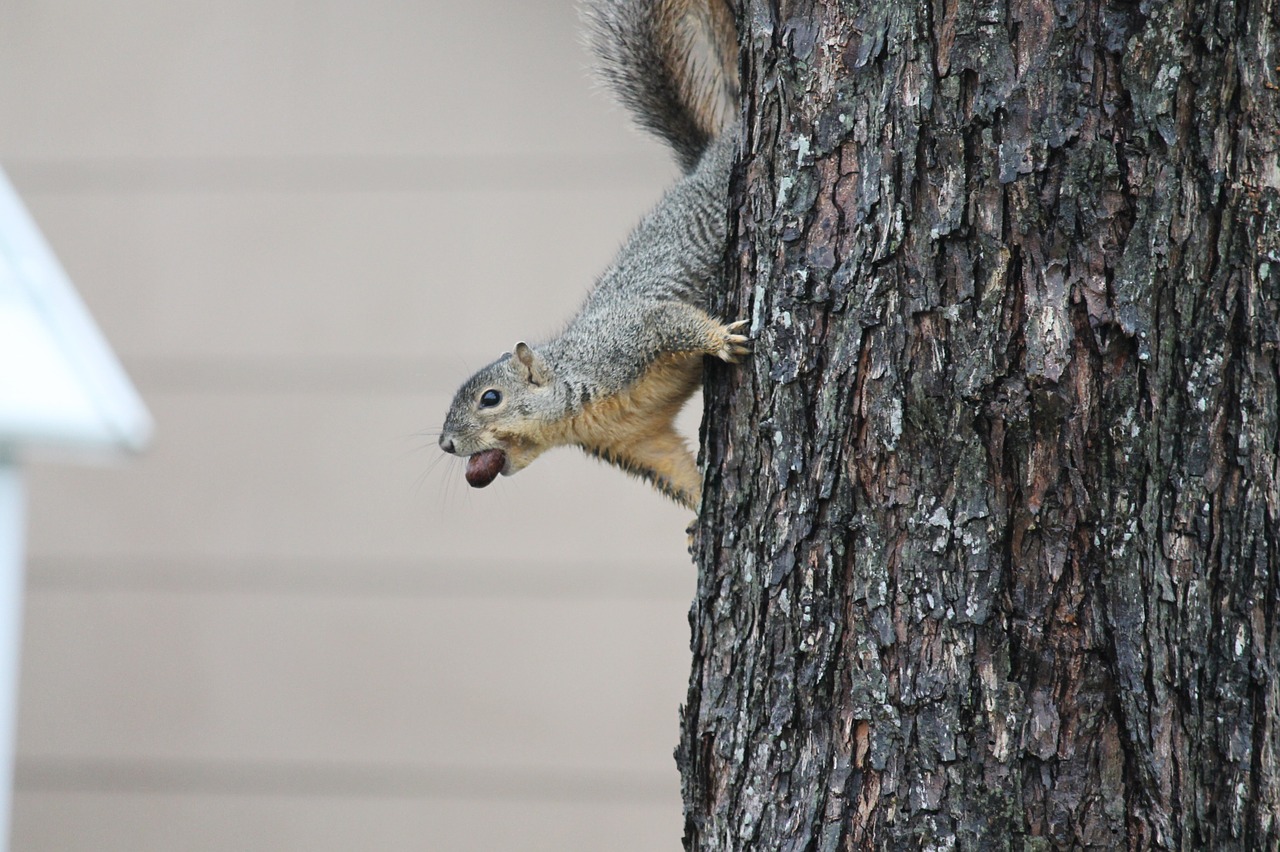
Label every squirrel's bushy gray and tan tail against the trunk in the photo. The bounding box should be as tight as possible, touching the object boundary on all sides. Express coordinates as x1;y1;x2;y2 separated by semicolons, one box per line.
584;0;739;171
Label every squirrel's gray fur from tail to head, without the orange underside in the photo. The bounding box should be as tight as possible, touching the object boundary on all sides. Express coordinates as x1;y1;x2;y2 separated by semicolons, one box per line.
440;0;744;478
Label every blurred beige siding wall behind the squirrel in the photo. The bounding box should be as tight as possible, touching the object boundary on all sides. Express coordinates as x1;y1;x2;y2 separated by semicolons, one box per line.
0;0;698;852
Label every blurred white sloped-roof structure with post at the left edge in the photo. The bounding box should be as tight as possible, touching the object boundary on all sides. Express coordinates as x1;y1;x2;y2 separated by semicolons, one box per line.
0;163;151;851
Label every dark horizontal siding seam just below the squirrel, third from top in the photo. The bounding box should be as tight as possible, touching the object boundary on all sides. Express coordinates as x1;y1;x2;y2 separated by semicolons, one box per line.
27;555;694;603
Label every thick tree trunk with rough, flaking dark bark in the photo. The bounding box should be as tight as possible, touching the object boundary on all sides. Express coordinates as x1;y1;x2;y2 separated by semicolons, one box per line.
677;0;1280;851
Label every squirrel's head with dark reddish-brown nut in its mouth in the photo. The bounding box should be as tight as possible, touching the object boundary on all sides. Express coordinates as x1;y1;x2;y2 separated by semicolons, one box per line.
440;343;563;487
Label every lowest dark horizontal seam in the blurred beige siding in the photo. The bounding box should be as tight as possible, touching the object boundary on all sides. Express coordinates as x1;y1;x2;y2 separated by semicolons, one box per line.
14;757;680;802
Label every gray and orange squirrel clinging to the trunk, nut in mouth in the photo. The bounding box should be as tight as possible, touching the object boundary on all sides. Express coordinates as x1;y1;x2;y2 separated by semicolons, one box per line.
440;0;749;509
